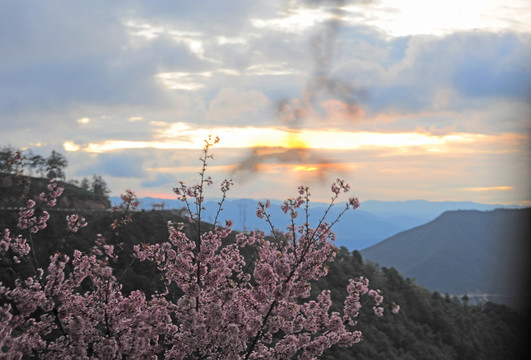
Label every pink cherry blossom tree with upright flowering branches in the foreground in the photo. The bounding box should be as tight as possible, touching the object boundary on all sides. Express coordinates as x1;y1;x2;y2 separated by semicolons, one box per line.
0;138;398;359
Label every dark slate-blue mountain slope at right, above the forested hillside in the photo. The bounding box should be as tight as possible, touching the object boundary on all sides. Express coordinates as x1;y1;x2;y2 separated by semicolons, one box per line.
361;208;531;310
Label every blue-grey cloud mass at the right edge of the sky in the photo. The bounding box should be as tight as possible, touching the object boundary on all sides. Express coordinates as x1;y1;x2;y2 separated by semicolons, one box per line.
334;31;531;114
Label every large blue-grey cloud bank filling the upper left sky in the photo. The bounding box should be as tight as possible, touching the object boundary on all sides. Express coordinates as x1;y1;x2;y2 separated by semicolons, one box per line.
0;2;216;116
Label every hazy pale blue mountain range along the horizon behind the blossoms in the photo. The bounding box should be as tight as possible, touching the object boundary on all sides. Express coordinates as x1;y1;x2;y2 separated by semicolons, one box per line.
111;197;520;250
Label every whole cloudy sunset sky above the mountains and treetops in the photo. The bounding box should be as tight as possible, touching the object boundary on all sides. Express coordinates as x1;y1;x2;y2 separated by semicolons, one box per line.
0;0;531;205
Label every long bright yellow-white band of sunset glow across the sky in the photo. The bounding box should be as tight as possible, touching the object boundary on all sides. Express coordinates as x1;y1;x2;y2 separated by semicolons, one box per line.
63;123;526;153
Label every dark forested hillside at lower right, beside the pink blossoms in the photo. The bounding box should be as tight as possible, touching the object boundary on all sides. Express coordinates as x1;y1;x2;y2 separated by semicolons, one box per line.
316;248;528;360
